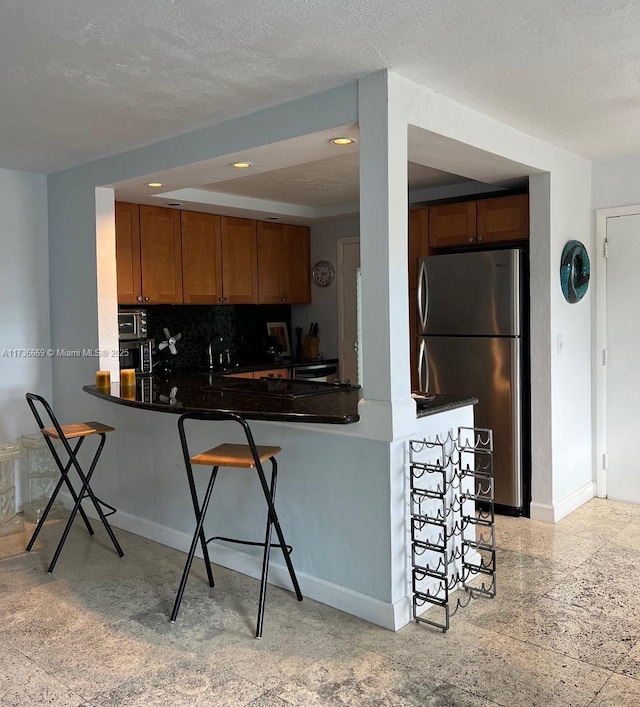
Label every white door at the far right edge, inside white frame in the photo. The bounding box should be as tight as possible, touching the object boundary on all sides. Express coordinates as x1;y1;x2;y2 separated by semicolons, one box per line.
605;214;640;503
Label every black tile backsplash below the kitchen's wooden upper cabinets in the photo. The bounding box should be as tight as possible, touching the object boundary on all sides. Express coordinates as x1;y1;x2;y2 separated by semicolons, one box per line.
146;304;291;368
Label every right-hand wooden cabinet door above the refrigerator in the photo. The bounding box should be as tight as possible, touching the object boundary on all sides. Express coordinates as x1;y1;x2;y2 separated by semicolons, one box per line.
476;194;529;243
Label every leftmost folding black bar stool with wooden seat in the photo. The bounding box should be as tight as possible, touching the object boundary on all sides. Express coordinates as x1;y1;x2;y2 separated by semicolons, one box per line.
25;393;124;574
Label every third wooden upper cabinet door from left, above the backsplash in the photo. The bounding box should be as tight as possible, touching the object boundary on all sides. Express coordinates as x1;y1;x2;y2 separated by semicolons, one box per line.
181;211;223;304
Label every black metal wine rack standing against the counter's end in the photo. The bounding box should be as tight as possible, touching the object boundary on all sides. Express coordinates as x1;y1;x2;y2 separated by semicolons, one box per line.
409;427;496;632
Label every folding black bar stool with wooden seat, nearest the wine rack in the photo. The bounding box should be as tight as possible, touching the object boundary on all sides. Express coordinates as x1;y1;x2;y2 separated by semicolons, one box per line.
170;412;302;638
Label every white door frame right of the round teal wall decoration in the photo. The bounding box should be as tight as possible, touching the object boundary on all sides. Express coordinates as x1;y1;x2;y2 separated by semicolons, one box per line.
592;205;640;498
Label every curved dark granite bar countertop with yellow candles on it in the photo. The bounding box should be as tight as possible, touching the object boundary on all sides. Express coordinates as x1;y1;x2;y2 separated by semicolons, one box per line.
83;365;361;425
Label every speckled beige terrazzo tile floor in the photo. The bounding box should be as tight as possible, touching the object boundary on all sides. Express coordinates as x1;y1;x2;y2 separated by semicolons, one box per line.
0;499;640;707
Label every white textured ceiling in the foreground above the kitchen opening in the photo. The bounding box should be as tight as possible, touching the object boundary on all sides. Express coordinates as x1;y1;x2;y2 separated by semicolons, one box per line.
0;0;640;172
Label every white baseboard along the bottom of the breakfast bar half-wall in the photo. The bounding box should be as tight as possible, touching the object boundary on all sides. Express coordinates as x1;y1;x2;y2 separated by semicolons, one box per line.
60;493;400;631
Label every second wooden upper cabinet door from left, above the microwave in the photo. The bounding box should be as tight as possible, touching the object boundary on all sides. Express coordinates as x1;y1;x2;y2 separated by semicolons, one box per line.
140;206;182;304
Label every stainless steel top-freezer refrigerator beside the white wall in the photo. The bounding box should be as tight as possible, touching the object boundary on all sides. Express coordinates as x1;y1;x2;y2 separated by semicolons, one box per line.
418;249;523;509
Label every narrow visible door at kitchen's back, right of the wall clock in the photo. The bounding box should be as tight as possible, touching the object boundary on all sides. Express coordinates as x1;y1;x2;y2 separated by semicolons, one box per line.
337;237;360;384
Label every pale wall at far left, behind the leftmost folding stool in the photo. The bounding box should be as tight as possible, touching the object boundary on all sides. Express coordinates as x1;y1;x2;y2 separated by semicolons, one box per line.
0;169;51;500
